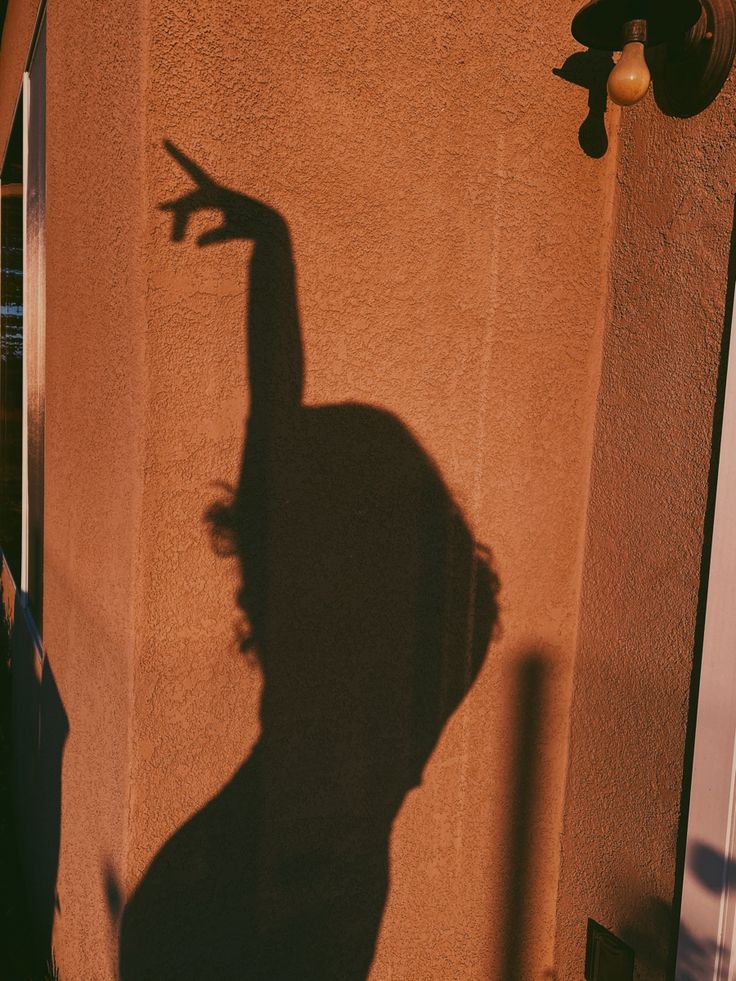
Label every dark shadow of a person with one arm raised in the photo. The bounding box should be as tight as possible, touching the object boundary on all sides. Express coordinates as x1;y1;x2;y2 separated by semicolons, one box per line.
120;143;497;981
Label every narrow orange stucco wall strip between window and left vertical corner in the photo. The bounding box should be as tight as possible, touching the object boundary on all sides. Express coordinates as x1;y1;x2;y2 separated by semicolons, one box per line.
44;0;145;979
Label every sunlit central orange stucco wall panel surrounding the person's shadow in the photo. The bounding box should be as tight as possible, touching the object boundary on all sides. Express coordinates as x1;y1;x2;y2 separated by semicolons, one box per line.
126;0;613;981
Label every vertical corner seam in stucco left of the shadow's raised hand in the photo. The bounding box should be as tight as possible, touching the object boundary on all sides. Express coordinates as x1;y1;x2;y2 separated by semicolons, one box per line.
122;0;150;899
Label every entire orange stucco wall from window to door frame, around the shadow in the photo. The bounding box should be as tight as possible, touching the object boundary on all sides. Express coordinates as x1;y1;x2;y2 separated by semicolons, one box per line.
0;0;731;981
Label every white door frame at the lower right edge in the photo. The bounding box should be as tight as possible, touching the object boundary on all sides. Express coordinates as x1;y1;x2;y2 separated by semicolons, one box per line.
675;292;736;981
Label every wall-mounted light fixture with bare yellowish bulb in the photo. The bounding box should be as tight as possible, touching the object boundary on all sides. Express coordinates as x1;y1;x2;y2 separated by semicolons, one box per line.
572;0;736;116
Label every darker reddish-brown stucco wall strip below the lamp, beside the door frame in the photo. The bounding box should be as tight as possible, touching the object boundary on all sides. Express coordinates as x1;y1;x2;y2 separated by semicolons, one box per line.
557;61;736;981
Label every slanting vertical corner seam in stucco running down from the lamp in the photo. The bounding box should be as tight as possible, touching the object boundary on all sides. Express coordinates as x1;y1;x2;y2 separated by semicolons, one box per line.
552;110;621;963
